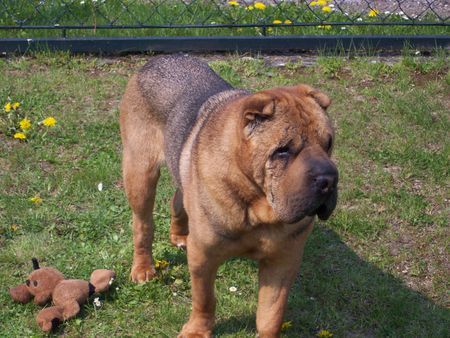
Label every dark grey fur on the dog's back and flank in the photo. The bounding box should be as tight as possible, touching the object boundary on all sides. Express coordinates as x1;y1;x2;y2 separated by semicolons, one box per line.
138;55;233;183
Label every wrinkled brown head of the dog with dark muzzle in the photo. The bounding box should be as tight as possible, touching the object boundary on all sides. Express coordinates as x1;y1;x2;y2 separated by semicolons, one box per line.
242;85;338;223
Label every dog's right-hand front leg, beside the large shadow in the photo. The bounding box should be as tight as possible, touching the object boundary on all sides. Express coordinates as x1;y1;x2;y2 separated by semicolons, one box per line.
256;224;312;338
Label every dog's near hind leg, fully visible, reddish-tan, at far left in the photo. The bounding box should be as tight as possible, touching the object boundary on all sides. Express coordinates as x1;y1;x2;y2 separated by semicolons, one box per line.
120;77;164;282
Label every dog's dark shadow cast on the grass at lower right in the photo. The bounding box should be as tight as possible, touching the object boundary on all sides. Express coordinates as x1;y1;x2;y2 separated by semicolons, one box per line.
215;225;450;337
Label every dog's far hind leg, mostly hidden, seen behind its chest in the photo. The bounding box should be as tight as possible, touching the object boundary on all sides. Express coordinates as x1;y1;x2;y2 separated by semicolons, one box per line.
170;189;189;249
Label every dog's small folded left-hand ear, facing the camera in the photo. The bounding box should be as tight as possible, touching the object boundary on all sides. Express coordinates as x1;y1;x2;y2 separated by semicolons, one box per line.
242;93;275;137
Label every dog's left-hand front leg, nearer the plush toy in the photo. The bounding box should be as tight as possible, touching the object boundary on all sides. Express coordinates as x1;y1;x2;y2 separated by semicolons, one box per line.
178;234;222;338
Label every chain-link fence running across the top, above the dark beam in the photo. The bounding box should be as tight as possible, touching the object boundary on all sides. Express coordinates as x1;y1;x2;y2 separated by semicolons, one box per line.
0;0;450;51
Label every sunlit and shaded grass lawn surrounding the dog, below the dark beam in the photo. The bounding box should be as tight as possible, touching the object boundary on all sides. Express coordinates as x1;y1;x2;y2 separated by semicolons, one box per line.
0;54;450;337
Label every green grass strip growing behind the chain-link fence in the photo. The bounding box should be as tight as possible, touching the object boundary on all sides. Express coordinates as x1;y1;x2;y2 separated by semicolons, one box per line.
0;0;449;38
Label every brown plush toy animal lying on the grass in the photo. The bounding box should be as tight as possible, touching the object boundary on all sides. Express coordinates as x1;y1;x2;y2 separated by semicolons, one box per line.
9;258;115;332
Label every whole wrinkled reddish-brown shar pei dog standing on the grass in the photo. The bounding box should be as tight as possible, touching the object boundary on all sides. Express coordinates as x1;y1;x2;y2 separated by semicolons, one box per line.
119;56;338;337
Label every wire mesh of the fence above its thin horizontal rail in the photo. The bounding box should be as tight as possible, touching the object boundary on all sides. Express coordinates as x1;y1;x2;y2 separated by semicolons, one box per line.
0;0;450;35
